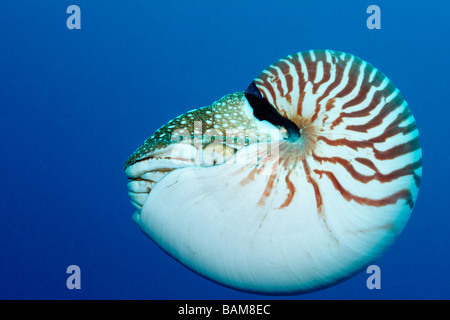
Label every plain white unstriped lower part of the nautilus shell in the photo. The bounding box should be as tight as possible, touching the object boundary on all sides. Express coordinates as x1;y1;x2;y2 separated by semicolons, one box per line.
134;144;409;294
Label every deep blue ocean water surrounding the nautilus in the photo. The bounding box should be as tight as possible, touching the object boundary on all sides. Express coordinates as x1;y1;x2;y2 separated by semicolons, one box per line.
0;0;450;299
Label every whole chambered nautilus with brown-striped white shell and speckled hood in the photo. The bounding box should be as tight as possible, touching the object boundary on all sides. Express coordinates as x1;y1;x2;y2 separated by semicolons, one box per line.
125;50;422;295
